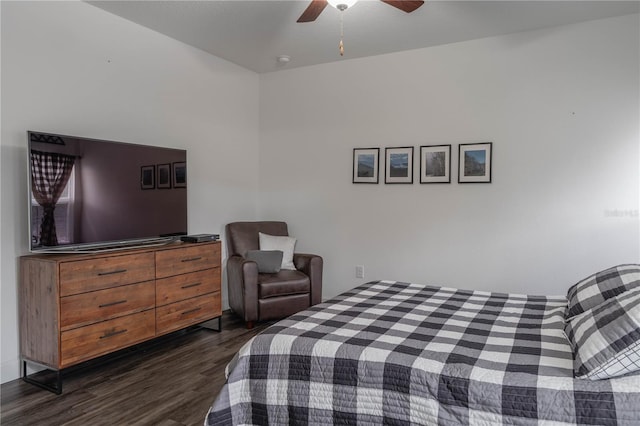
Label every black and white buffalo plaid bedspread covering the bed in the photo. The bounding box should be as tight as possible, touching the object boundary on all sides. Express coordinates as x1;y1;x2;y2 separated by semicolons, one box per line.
205;281;640;425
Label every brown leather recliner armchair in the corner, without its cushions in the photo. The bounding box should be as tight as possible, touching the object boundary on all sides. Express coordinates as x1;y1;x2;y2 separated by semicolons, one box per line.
225;222;323;329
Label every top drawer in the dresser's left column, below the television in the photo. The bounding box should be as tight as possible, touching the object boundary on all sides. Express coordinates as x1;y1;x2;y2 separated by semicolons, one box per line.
60;253;155;296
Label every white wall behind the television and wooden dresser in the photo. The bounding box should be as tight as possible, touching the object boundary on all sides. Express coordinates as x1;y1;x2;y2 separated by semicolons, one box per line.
0;1;259;382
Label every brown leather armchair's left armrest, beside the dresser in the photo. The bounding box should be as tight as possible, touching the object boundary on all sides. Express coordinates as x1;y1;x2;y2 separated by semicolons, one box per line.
227;255;258;322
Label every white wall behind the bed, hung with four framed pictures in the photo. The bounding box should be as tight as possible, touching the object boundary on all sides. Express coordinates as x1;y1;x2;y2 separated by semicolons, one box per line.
259;15;640;297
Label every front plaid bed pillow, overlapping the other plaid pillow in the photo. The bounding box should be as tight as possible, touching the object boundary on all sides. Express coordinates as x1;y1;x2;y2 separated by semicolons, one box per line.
564;287;640;380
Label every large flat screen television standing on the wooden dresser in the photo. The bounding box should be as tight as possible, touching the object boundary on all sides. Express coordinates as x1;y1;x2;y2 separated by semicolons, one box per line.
27;131;187;252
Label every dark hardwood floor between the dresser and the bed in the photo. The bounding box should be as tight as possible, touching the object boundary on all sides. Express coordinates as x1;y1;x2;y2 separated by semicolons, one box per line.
0;312;272;426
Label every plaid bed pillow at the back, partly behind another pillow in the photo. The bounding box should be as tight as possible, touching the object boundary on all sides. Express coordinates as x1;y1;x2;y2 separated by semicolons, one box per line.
566;264;640;319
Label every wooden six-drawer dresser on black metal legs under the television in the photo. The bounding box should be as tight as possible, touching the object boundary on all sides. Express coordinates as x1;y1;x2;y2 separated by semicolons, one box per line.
19;242;222;393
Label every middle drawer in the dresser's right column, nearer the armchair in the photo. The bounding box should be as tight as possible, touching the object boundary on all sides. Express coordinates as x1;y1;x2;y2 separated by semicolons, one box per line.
156;268;220;306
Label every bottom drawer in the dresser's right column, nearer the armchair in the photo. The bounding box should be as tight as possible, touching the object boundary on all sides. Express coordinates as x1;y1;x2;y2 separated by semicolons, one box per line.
156;293;222;335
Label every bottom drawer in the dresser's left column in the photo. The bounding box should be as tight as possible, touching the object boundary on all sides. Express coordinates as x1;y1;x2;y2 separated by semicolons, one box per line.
60;309;155;367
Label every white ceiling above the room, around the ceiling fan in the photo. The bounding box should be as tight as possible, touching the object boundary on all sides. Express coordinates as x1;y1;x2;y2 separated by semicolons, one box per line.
88;0;640;73
